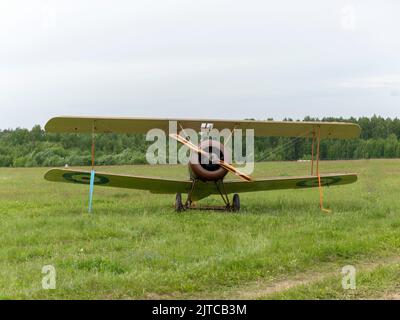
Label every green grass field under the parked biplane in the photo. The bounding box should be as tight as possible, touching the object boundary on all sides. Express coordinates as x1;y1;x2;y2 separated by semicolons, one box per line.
0;160;400;299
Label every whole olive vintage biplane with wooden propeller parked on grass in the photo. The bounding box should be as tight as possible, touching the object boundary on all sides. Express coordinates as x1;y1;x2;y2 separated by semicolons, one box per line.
45;117;361;212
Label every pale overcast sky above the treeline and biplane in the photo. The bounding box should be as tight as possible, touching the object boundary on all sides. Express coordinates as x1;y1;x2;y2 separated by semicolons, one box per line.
0;0;400;129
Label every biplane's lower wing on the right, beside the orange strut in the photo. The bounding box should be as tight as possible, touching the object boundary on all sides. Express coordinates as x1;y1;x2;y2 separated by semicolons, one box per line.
225;174;357;193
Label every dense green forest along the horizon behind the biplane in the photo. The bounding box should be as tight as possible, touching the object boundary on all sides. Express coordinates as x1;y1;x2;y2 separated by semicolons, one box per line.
0;116;400;167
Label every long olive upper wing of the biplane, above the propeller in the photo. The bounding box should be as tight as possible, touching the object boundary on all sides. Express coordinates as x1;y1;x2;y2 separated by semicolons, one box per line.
46;117;361;139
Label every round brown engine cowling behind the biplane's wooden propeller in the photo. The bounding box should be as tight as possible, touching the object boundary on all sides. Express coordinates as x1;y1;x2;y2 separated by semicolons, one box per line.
189;140;231;181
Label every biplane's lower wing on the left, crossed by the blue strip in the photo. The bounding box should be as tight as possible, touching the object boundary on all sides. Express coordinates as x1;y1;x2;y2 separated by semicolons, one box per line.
45;169;191;194
